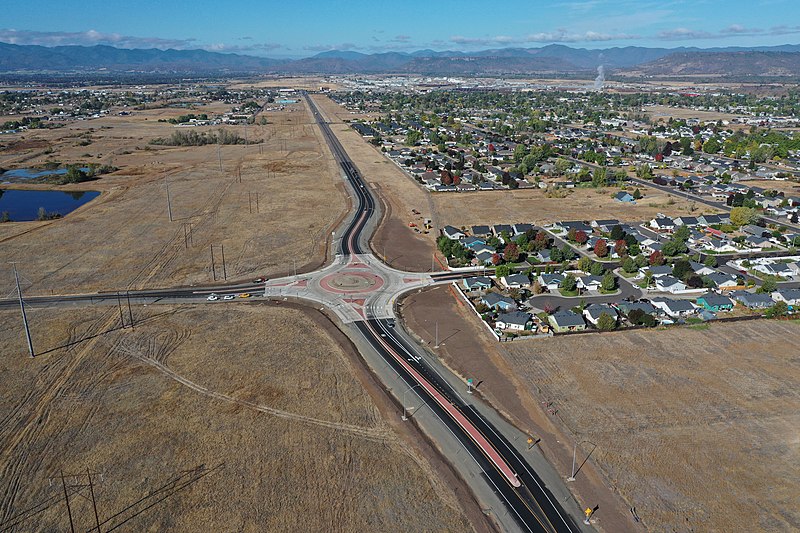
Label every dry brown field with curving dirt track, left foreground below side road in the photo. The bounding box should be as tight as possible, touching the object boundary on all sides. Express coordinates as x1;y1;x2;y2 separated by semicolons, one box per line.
0;304;476;531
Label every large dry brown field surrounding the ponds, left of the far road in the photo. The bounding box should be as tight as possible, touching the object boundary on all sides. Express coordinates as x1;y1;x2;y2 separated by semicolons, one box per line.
0;97;347;294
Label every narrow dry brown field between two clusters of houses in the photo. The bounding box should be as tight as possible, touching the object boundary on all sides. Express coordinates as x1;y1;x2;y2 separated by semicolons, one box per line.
432;187;716;227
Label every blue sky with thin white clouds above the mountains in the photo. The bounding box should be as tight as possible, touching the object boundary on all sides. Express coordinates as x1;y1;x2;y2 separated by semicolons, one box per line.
0;0;800;57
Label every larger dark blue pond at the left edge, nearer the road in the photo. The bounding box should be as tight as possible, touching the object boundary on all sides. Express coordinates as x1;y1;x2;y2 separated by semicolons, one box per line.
0;189;100;222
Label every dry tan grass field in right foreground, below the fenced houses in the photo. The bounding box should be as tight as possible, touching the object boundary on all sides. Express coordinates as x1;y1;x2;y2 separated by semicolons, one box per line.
505;321;800;532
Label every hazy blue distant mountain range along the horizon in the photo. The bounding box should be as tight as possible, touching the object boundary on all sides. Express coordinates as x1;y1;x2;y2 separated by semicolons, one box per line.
0;43;800;77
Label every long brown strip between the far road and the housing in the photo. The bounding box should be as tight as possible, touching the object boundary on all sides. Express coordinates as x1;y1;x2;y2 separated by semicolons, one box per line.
313;95;438;271
